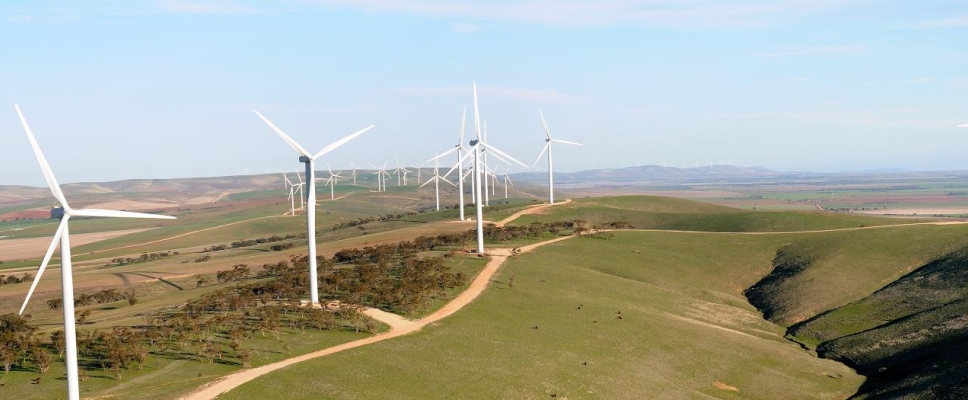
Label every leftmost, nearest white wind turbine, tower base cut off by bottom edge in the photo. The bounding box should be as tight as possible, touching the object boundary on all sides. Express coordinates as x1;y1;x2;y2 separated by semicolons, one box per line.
14;104;175;400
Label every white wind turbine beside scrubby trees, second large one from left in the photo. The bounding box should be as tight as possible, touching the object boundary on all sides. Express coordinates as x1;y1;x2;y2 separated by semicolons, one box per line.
255;111;374;306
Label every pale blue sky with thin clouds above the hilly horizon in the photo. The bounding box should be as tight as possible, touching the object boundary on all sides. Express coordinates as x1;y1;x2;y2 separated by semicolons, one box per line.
0;0;968;186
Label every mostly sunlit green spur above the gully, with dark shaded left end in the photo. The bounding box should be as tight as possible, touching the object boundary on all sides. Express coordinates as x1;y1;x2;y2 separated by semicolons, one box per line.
746;225;968;326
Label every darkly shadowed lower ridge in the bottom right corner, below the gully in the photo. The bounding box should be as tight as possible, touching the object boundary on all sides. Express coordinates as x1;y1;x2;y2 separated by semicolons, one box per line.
790;248;968;397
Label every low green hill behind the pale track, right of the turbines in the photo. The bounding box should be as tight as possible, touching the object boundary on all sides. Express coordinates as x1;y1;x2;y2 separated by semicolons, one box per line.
514;196;917;232
